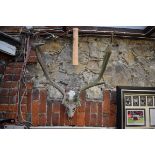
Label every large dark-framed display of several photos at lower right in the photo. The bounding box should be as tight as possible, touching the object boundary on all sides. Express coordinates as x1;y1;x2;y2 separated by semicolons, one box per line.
116;86;155;129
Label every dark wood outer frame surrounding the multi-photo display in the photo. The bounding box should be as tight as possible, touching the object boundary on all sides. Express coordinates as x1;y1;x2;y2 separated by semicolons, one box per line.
116;86;155;129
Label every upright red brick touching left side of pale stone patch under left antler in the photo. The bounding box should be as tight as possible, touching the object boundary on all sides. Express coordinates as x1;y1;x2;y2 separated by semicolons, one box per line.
39;89;47;113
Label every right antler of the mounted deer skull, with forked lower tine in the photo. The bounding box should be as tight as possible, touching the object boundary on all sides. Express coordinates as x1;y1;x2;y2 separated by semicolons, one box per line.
80;45;112;93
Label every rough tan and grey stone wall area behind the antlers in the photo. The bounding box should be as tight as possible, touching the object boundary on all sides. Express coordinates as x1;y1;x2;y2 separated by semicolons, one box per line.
28;37;155;100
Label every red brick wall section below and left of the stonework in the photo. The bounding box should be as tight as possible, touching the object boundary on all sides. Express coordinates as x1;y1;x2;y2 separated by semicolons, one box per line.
0;52;116;127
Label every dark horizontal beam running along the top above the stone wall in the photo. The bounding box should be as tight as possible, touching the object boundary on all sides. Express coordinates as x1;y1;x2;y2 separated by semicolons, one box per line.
0;26;155;40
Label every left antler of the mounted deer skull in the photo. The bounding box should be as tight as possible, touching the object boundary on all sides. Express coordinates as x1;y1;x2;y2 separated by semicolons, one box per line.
35;47;66;98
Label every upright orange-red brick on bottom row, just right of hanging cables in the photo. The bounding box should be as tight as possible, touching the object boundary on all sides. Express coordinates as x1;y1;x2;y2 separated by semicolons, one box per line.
32;100;39;126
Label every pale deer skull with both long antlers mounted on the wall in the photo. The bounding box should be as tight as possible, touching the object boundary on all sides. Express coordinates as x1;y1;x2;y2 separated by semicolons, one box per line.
34;44;112;118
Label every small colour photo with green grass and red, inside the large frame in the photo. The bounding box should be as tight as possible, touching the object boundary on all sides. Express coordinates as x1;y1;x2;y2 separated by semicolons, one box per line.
126;109;145;126
